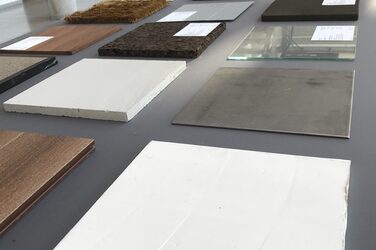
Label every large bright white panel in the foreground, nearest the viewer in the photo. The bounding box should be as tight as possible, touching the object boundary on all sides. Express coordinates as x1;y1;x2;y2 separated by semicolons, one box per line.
56;141;350;250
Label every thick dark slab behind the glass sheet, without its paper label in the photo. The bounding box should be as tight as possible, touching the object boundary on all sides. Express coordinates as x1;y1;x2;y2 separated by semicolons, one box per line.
261;0;359;21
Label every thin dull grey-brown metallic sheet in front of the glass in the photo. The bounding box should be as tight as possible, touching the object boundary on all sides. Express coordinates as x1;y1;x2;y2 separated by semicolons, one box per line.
173;68;354;138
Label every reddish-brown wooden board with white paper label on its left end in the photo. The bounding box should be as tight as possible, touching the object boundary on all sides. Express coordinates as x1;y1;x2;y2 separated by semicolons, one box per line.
0;25;121;55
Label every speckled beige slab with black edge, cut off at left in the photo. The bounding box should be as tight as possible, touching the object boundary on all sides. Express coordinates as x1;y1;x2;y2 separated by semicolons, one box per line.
0;56;57;94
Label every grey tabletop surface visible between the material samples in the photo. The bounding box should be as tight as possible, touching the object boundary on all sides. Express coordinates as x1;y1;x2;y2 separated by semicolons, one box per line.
0;0;376;250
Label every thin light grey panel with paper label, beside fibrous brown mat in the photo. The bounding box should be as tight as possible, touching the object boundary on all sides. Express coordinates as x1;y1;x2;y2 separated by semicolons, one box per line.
158;1;253;22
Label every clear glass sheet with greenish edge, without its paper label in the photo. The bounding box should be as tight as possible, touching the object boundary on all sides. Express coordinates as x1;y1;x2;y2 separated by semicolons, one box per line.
228;26;357;60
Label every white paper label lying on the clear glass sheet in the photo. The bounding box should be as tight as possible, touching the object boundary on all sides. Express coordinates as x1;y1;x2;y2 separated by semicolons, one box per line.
311;26;355;41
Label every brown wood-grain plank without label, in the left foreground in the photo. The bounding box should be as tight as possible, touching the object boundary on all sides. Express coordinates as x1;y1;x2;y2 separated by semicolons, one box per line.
0;131;94;233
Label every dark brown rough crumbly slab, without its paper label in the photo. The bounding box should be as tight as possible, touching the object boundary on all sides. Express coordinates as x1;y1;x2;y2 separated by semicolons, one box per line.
98;22;226;58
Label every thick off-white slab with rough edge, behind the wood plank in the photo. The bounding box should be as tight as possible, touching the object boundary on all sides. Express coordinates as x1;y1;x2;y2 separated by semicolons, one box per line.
3;59;186;121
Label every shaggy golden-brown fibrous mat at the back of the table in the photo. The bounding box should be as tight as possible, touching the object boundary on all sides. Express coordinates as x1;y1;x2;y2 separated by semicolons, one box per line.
65;0;168;23
